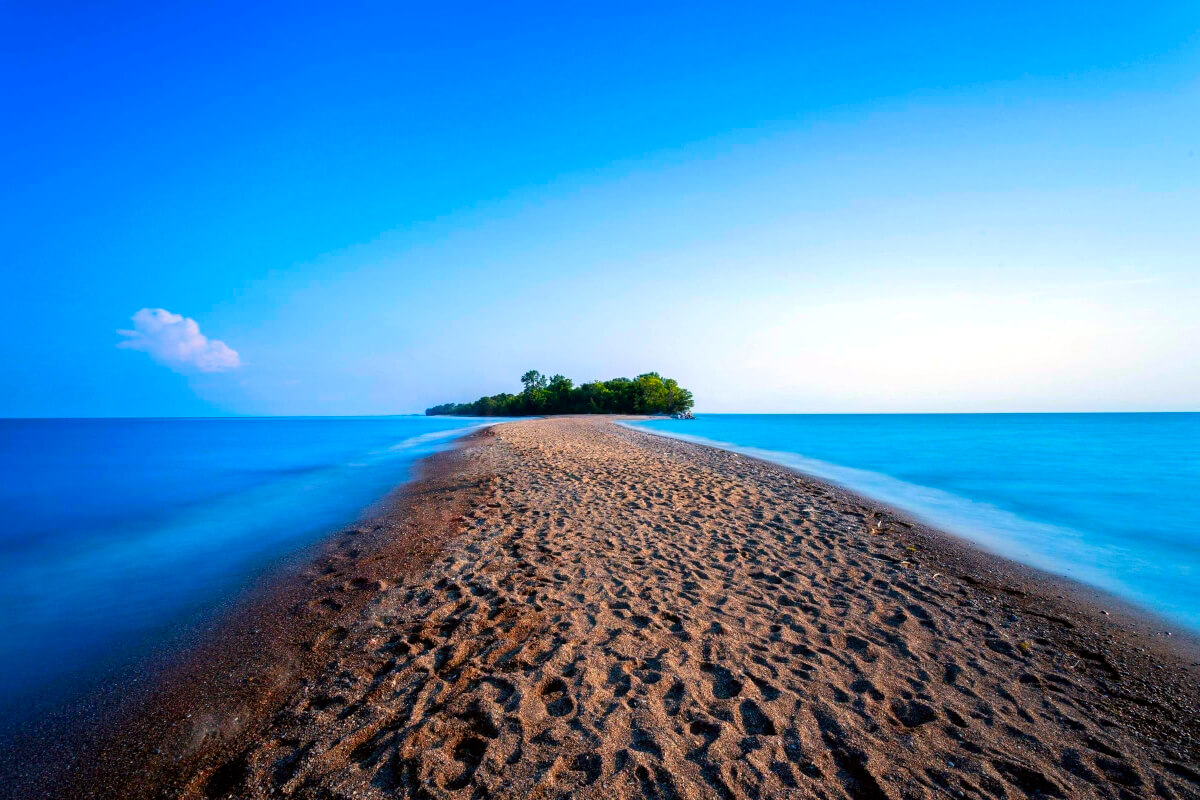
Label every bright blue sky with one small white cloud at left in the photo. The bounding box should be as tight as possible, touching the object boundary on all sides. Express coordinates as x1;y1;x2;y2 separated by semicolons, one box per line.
0;1;1200;416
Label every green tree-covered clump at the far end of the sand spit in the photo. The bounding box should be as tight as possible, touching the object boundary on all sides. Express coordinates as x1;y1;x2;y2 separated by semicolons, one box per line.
425;369;692;416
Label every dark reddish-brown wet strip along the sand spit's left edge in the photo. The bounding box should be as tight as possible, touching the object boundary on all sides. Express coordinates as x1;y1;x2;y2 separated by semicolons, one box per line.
6;425;504;800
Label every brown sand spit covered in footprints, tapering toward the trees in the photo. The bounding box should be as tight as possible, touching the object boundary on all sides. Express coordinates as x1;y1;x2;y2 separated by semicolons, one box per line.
42;417;1200;800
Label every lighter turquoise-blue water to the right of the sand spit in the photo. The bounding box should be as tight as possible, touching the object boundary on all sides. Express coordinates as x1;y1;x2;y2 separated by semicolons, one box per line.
634;414;1200;631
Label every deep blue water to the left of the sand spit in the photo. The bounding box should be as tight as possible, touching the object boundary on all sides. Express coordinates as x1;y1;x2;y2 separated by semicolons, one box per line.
0;416;494;717
